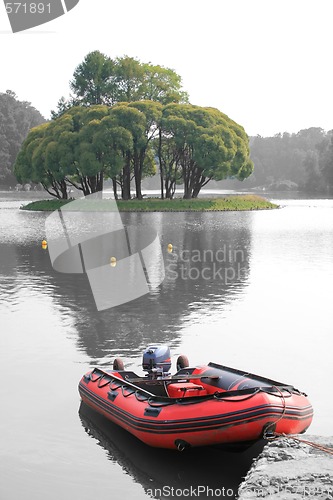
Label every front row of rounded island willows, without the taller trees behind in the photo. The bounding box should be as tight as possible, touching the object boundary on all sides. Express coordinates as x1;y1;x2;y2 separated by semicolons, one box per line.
15;101;253;199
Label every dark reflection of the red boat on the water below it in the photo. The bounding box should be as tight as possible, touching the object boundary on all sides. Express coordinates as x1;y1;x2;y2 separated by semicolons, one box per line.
79;403;263;498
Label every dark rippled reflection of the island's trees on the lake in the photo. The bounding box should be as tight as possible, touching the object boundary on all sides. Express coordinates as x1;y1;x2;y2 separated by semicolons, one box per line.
15;212;251;364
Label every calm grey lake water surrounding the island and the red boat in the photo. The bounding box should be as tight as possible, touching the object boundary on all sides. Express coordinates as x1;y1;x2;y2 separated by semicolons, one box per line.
0;193;333;500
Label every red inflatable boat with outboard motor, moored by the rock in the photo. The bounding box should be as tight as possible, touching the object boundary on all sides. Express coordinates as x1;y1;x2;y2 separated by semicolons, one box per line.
79;346;313;450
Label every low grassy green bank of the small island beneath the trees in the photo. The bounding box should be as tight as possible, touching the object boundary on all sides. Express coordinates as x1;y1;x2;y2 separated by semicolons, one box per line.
21;194;279;212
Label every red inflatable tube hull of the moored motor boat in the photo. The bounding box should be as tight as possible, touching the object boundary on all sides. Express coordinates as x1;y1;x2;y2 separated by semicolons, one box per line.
79;367;313;450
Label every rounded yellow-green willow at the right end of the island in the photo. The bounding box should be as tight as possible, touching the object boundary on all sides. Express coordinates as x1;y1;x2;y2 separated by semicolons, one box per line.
158;104;253;198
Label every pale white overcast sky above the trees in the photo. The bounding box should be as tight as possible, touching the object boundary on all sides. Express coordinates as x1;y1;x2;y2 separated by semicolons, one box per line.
0;0;333;136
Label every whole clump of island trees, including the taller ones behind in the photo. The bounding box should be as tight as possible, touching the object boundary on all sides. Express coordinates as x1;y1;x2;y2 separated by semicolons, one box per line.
15;51;253;199
